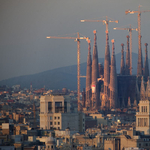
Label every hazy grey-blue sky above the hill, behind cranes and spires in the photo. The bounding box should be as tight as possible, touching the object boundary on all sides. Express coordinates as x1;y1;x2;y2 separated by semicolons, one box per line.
0;0;150;80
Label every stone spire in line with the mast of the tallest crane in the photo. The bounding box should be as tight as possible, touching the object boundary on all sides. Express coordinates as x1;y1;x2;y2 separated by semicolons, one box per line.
137;35;143;76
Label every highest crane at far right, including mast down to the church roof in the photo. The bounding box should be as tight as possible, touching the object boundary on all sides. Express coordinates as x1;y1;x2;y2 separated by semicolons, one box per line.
125;5;150;75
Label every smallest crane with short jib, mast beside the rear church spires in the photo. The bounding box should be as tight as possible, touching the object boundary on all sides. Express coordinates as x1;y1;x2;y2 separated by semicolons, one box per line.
114;25;138;75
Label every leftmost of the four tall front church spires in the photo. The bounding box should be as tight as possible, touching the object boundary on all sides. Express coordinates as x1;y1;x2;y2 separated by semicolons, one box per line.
86;40;92;107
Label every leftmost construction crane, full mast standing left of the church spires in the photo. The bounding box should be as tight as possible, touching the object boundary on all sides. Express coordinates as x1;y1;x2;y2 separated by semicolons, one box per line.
46;32;89;111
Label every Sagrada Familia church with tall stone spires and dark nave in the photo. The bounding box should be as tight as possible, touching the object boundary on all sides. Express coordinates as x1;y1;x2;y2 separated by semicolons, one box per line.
83;30;150;110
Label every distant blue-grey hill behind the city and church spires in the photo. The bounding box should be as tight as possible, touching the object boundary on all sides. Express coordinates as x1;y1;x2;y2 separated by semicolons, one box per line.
0;53;150;90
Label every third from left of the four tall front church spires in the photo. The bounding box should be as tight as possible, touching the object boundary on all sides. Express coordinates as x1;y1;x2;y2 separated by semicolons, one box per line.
102;31;110;107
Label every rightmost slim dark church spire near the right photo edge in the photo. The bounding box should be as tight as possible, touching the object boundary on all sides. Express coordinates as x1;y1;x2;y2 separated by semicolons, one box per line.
143;43;149;81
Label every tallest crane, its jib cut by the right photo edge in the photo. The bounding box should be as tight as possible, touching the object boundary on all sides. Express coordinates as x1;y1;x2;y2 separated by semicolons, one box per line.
125;5;150;75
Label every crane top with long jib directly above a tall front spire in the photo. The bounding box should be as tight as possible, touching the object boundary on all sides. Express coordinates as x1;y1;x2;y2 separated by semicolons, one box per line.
80;16;118;33
